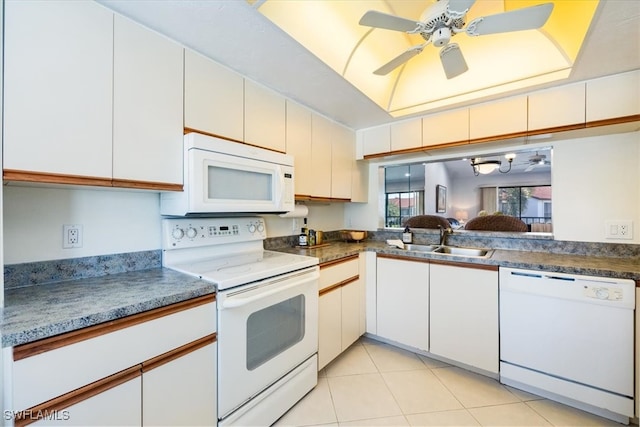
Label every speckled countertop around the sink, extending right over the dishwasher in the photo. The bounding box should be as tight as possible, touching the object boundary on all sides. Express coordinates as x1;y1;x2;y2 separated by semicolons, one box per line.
277;240;640;281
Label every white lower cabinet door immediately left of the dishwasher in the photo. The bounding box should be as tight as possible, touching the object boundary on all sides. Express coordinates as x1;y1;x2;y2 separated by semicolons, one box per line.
429;264;498;373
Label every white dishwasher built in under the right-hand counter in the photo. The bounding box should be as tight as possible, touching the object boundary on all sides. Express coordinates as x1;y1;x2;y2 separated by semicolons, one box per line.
500;268;635;423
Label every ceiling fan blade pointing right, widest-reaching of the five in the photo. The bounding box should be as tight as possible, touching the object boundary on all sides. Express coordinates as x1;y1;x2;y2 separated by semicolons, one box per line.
465;3;553;36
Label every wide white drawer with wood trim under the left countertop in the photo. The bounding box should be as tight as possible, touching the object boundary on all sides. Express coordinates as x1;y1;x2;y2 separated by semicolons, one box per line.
13;295;216;410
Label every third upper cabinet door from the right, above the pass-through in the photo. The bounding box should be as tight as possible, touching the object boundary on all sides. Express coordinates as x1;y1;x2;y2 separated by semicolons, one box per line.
469;96;527;140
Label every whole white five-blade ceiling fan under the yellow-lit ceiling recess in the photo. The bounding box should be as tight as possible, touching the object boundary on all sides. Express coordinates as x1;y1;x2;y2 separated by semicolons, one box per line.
360;0;553;79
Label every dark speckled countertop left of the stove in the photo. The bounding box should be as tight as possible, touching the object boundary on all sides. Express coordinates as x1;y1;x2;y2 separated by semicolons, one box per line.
0;268;215;347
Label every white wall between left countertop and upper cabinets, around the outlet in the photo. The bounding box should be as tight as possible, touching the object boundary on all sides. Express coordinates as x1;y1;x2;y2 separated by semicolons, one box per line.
3;186;160;264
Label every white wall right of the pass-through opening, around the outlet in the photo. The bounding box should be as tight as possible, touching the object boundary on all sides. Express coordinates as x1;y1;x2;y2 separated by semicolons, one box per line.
552;132;640;243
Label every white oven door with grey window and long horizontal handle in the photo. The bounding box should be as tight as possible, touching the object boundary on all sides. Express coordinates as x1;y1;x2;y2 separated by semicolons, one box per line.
217;266;320;419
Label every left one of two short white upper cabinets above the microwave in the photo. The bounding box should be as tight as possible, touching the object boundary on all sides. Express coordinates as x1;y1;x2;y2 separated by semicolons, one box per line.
184;49;244;141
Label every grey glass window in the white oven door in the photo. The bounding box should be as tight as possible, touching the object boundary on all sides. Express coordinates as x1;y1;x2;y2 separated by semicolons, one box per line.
247;295;305;371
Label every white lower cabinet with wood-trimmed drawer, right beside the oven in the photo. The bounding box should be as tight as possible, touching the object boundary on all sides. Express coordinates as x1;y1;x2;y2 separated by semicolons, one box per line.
318;255;364;370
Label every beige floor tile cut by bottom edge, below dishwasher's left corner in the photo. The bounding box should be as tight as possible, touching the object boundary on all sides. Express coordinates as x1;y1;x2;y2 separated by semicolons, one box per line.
469;402;551;427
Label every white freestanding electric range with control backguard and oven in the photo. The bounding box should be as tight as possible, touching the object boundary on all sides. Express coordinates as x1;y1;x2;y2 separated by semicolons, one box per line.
162;217;320;426
